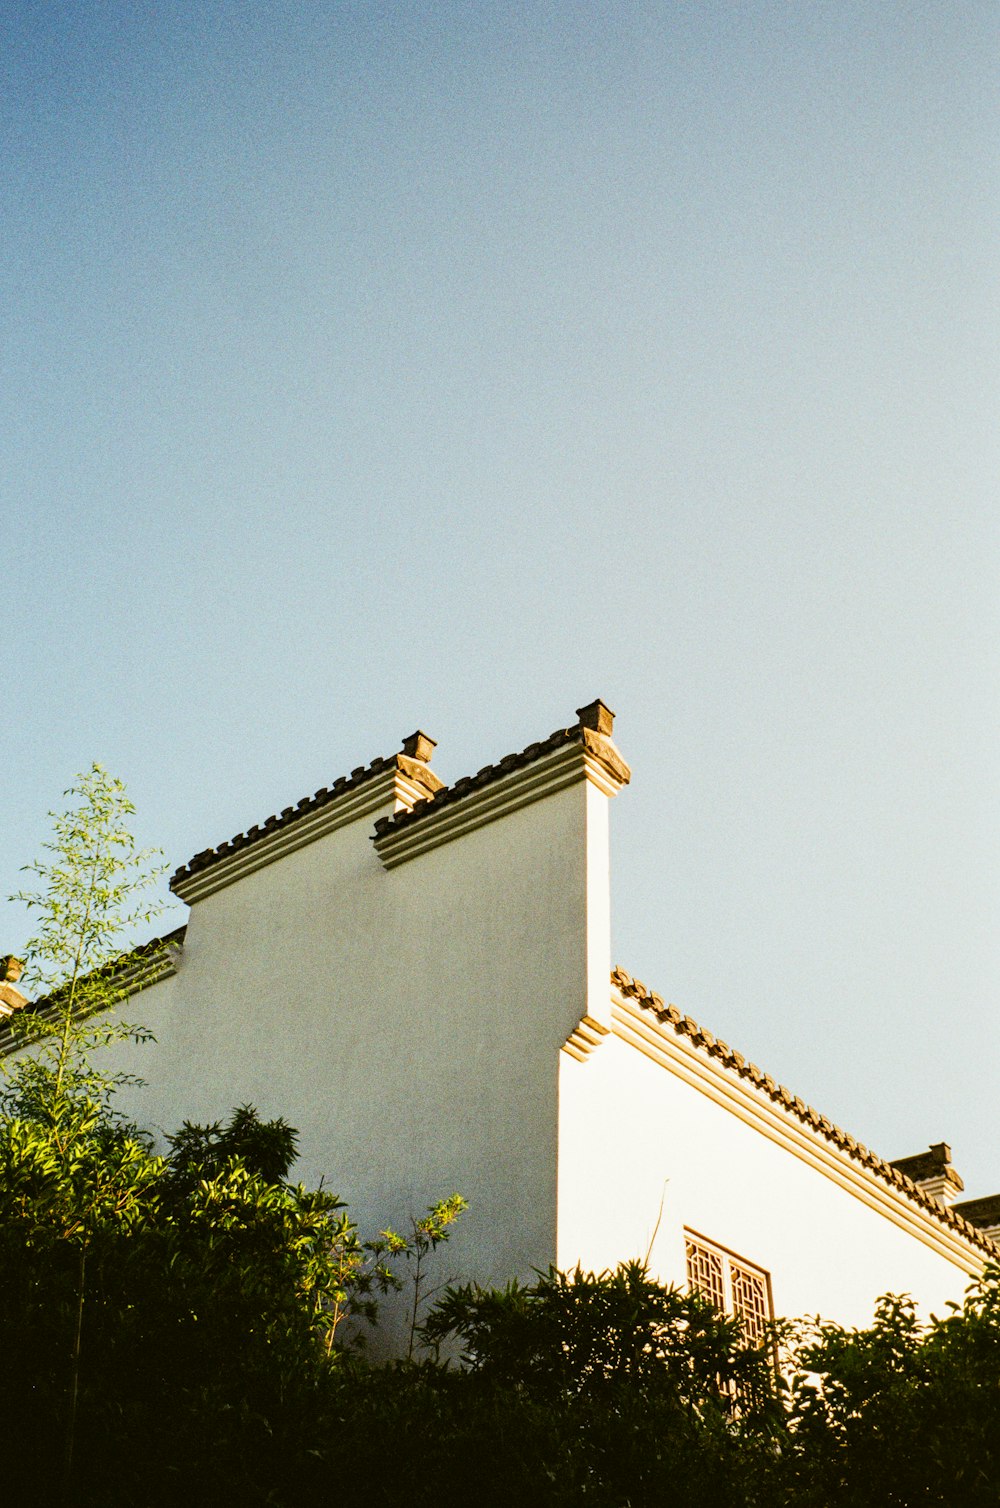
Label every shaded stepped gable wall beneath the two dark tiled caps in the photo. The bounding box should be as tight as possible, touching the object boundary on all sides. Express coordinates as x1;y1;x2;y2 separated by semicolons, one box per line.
101;771;609;1351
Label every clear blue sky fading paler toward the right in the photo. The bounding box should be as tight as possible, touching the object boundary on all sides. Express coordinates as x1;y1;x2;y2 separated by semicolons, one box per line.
0;0;1000;1196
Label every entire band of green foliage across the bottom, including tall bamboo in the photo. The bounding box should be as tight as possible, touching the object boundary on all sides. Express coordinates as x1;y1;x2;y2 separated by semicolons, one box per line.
7;766;1000;1508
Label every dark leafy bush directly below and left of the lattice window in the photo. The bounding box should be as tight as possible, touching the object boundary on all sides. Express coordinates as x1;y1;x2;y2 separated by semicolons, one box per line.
398;1262;780;1505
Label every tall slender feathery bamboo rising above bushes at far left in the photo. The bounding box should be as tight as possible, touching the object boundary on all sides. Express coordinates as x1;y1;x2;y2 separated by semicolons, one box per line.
0;765;165;1497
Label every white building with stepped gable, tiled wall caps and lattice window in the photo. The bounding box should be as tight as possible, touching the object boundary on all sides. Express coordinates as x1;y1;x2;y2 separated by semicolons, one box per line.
3;701;1000;1351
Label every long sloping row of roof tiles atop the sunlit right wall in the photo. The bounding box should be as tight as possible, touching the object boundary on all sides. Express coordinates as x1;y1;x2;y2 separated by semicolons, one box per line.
611;968;997;1256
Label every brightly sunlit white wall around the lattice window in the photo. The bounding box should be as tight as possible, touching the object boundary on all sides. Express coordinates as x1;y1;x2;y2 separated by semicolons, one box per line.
558;1036;977;1326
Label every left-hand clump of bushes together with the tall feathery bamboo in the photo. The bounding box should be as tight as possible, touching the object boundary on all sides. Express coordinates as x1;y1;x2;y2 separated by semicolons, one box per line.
0;765;460;1503
